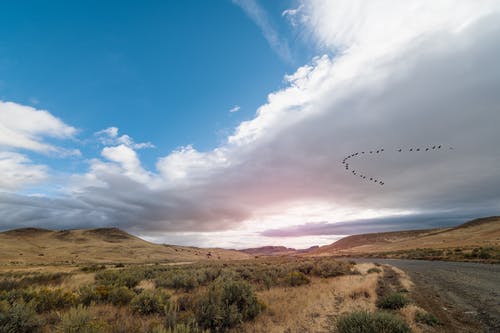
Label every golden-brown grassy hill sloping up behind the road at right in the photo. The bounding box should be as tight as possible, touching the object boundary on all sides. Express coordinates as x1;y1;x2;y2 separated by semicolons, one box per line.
307;216;500;255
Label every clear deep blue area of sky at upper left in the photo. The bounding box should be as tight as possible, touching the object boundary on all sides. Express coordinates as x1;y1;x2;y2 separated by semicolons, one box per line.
0;1;309;168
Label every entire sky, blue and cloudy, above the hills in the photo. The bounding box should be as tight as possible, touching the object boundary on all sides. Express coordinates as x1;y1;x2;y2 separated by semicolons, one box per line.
0;0;500;248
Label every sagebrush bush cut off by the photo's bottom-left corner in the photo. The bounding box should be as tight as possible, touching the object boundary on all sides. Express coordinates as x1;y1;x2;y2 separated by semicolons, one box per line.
0;302;43;333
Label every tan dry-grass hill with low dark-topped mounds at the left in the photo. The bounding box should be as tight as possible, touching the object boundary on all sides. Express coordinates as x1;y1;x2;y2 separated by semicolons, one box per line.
0;228;251;264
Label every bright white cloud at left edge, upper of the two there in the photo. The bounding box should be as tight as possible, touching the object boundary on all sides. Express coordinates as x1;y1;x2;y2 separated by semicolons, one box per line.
0;101;77;155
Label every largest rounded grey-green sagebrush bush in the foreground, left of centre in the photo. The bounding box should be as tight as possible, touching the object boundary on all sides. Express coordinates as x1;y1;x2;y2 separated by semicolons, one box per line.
196;279;264;332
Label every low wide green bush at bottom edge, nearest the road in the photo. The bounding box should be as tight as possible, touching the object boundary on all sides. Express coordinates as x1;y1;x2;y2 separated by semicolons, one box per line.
336;311;411;333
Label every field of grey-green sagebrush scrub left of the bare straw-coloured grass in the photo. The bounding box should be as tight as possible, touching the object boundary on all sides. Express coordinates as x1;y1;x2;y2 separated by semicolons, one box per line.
0;257;418;333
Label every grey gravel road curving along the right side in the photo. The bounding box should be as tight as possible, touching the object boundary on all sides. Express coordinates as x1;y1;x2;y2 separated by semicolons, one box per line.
357;259;500;333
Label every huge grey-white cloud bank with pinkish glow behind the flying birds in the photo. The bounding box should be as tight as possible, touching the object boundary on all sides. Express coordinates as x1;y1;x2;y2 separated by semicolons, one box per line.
0;0;500;245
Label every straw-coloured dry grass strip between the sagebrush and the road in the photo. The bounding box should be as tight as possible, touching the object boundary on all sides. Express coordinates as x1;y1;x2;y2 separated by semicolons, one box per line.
234;264;378;333
